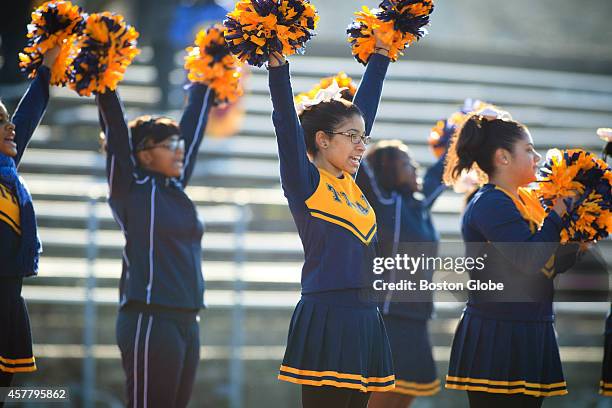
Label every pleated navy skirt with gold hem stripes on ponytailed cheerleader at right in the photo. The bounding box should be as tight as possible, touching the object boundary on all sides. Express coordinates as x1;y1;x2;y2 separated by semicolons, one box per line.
446;312;567;397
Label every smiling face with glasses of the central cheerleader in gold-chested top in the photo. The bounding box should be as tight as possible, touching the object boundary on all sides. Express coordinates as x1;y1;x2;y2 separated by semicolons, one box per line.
315;115;366;175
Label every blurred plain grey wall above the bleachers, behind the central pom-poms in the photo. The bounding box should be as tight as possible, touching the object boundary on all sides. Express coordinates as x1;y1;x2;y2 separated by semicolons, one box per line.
310;0;612;74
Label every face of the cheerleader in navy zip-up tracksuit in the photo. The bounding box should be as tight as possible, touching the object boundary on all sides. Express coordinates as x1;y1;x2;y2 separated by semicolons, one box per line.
136;135;185;177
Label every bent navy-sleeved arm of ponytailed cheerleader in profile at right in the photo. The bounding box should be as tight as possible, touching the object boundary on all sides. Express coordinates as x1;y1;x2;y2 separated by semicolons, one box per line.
469;191;562;273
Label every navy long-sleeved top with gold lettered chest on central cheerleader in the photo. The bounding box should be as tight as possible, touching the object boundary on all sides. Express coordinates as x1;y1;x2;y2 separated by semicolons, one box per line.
269;55;389;293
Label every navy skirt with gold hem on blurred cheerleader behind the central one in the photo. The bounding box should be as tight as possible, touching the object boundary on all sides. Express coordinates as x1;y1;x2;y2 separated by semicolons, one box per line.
383;315;440;396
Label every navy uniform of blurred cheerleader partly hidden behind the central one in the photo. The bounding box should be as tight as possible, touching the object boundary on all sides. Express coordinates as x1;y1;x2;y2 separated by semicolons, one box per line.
358;155;446;396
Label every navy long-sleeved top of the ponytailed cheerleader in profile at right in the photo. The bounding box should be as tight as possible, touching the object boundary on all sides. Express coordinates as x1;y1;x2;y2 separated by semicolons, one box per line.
461;184;575;321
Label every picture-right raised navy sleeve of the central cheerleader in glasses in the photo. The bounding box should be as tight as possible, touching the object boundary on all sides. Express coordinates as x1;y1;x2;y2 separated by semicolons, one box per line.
353;54;390;135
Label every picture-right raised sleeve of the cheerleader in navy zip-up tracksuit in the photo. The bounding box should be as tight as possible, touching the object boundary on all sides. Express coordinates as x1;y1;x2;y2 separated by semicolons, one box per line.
180;83;215;186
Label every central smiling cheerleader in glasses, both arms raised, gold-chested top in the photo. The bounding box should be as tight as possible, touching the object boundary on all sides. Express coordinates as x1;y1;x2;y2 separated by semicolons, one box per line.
268;38;394;408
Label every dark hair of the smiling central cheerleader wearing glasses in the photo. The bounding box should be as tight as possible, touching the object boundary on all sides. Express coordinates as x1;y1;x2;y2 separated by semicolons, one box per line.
300;99;363;156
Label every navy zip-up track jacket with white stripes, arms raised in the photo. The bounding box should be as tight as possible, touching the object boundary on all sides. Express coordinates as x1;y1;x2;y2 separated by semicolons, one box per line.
96;84;214;309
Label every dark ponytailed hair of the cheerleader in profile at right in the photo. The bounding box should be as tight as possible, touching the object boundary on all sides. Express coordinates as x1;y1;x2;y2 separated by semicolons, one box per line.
444;114;527;185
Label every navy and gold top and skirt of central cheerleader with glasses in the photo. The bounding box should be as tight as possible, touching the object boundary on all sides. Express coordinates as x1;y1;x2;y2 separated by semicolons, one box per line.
269;55;394;392
